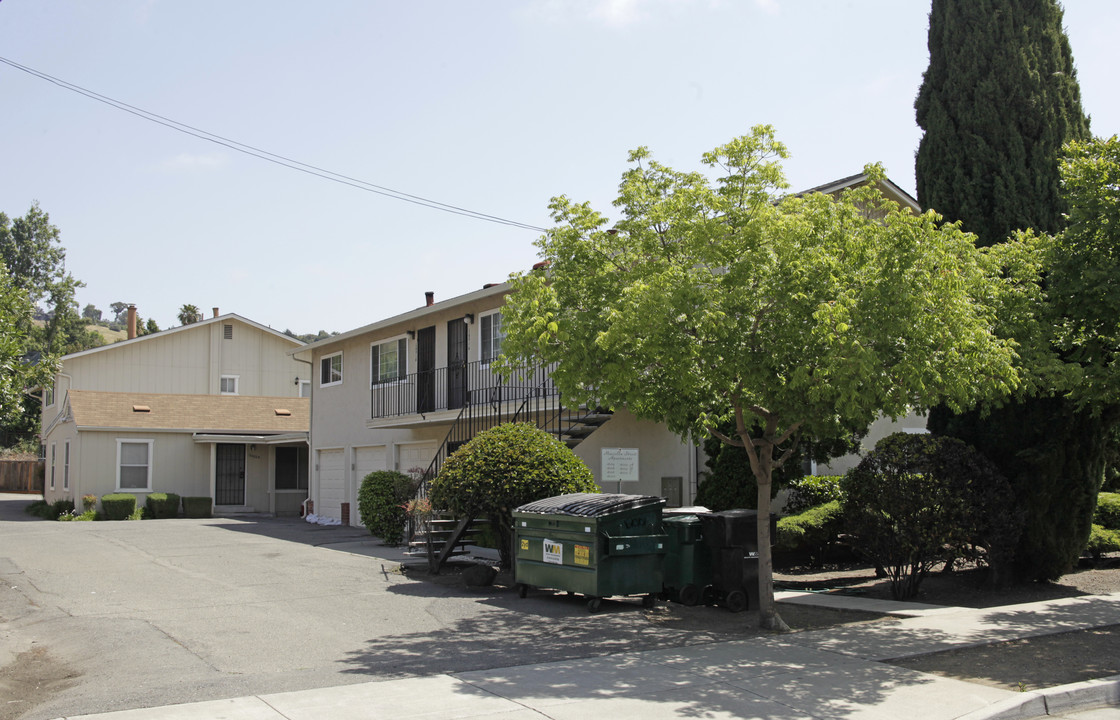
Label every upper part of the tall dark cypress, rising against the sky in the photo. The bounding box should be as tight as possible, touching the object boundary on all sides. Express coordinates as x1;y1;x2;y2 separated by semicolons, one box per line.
914;0;1090;245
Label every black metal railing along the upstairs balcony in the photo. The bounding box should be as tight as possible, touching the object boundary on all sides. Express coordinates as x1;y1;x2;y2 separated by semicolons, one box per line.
370;362;559;419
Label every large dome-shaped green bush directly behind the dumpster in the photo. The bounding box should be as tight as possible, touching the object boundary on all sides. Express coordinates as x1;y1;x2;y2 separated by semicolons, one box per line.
429;423;599;567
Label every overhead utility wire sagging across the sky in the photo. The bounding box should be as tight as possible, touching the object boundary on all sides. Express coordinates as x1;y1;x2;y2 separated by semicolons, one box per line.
0;57;545;233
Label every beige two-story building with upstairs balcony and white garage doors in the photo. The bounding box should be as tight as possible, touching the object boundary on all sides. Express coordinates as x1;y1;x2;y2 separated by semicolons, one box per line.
293;283;698;524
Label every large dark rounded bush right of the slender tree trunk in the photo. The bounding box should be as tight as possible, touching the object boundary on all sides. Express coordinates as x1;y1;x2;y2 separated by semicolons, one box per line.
842;432;1021;600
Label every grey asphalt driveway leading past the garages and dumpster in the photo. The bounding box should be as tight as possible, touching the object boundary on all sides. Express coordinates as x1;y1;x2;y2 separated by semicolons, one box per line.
0;494;754;720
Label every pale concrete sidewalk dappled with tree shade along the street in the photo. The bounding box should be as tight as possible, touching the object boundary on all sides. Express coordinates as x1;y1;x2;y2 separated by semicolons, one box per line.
54;593;1120;720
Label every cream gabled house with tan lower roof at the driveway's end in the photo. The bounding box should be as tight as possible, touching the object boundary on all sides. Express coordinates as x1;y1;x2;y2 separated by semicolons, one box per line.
41;308;310;514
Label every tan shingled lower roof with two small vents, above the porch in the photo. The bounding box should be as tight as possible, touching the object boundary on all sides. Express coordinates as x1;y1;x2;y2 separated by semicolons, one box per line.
65;390;311;434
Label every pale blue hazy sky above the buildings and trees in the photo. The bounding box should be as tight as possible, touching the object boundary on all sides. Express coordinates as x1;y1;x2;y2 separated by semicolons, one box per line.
0;0;1120;334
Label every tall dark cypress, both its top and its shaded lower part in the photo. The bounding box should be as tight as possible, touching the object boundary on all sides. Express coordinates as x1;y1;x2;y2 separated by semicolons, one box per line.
914;0;1111;580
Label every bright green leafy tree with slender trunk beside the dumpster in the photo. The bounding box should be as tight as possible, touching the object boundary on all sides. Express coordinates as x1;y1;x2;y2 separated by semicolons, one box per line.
502;127;1016;629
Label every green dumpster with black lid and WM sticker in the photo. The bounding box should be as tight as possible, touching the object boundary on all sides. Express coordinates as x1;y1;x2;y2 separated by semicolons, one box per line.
513;493;666;613
